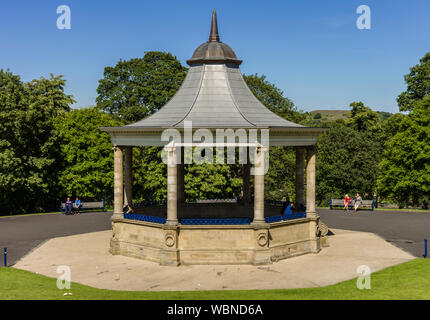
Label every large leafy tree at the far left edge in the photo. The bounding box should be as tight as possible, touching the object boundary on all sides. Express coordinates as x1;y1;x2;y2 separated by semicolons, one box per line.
0;70;74;214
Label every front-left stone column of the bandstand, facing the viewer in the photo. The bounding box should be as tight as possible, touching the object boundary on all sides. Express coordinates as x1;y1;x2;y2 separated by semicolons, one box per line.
166;147;178;225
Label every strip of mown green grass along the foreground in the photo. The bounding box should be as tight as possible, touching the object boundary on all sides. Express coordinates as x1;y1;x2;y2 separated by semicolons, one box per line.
0;258;430;300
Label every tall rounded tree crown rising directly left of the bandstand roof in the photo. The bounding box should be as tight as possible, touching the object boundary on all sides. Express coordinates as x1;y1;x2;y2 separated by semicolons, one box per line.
96;51;187;123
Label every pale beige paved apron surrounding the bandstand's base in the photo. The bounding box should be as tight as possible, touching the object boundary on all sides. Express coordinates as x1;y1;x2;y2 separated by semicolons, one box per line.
14;229;414;291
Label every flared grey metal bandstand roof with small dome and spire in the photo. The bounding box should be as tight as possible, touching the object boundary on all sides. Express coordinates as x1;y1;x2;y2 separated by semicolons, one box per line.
125;12;304;128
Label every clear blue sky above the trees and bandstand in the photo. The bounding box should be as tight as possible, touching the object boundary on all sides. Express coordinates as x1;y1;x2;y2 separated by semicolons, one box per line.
0;0;430;112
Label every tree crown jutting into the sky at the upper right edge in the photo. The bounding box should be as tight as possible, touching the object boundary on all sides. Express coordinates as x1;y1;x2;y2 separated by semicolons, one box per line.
397;52;430;111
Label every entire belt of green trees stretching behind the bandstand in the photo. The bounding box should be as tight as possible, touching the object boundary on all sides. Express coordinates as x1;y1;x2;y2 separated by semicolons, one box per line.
0;52;430;214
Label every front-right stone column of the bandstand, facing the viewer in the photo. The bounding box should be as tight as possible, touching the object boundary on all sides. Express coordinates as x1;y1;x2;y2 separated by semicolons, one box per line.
253;147;266;224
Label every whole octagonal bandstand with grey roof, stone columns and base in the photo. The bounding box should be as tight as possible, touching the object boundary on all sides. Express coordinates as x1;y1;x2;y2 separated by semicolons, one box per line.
100;11;324;266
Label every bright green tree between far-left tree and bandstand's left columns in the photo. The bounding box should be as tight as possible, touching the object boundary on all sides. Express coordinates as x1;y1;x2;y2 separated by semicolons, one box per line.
55;107;121;200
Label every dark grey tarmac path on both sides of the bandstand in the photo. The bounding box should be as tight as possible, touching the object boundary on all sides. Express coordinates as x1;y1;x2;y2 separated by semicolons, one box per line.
0;209;430;265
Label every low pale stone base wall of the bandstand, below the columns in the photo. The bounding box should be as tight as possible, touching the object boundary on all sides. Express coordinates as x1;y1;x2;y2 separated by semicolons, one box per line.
110;218;320;266
